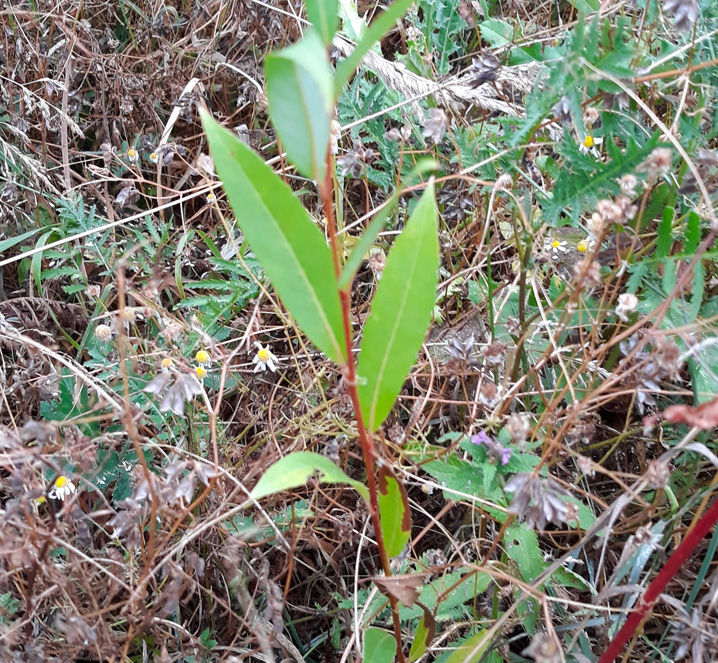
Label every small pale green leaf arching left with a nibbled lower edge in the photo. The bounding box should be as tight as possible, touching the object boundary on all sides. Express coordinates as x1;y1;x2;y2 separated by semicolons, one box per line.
251;451;369;501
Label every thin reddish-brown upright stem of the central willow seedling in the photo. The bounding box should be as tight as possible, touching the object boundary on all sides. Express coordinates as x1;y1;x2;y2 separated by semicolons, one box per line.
319;153;404;663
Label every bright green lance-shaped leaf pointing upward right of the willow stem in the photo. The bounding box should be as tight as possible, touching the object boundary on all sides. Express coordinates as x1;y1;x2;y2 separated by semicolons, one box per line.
357;185;439;431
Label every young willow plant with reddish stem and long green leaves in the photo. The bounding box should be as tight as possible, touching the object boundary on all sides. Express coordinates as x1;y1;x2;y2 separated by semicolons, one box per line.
202;0;439;661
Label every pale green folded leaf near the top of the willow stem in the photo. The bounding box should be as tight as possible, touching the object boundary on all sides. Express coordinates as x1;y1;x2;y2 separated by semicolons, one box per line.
265;30;332;182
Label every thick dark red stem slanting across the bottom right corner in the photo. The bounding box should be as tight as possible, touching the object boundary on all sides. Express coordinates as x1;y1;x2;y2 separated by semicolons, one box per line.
598;499;718;663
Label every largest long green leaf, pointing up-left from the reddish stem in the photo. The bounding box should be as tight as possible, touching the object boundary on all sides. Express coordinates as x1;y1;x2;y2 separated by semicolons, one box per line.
202;111;346;364
